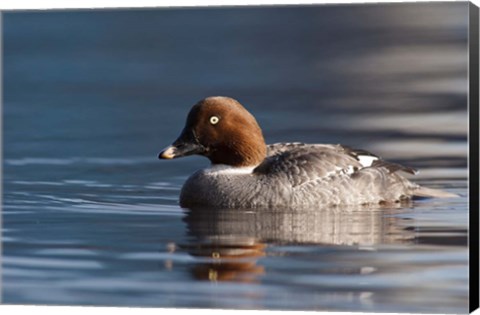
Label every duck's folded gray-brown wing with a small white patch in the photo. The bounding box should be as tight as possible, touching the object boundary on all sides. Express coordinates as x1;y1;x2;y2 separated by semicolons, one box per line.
254;143;416;187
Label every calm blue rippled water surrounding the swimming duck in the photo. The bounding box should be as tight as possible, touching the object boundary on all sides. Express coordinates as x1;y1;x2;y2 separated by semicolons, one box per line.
2;3;468;313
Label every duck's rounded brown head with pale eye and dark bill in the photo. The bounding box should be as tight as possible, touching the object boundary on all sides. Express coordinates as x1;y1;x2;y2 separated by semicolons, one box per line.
158;96;266;167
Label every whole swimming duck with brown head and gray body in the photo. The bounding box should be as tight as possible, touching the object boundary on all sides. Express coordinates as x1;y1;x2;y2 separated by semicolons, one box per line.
158;96;457;209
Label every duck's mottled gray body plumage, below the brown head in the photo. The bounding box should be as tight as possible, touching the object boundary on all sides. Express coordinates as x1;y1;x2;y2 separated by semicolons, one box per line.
180;143;421;208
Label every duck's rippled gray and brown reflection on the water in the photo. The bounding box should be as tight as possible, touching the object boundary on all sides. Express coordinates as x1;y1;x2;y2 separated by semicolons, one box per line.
181;204;414;282
